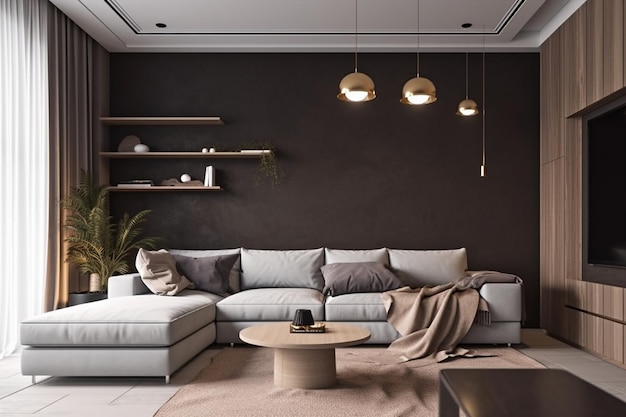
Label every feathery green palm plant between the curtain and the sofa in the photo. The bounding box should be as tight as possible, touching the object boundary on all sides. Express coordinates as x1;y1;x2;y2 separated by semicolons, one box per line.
62;170;160;293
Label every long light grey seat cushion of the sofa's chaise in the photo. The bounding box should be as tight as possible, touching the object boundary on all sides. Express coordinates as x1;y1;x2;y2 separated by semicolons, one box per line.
20;290;222;347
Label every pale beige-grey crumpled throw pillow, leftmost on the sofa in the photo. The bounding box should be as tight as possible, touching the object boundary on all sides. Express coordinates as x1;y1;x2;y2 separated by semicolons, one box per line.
135;249;193;295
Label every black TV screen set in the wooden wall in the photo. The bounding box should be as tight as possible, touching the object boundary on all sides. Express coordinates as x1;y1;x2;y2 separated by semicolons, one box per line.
586;105;626;268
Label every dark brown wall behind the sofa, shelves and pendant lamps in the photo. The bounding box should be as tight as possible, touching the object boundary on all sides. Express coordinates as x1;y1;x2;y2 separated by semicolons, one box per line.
110;54;539;326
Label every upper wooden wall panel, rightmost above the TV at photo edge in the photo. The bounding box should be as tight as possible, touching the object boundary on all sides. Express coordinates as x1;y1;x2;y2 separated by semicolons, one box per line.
602;0;624;96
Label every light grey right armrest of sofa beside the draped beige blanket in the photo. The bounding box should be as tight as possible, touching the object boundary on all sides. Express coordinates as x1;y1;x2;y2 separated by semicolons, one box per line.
479;282;524;321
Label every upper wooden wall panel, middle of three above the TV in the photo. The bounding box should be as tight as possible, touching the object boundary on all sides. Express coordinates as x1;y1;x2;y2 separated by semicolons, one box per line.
583;0;604;105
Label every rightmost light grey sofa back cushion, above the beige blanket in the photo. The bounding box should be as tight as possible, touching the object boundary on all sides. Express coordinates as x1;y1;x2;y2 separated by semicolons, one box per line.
388;248;467;288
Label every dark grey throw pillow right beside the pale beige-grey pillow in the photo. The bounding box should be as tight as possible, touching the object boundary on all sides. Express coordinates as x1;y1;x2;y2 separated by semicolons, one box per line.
173;254;239;295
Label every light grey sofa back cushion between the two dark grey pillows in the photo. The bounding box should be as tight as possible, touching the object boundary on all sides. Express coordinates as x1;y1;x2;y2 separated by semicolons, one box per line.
241;248;324;291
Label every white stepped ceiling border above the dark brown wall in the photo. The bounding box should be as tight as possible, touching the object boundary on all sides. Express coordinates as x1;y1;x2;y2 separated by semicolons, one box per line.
50;0;585;53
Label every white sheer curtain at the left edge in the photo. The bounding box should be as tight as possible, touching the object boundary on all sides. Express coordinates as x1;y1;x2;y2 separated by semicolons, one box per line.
0;0;49;358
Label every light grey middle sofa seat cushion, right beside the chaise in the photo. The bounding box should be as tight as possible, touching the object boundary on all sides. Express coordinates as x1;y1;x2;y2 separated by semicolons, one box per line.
217;288;324;321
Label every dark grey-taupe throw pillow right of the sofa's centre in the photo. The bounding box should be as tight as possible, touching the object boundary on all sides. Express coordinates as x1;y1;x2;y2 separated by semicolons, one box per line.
322;262;404;296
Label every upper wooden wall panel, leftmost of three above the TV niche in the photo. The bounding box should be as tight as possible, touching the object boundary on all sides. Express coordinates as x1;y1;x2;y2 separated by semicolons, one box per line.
561;8;587;116
